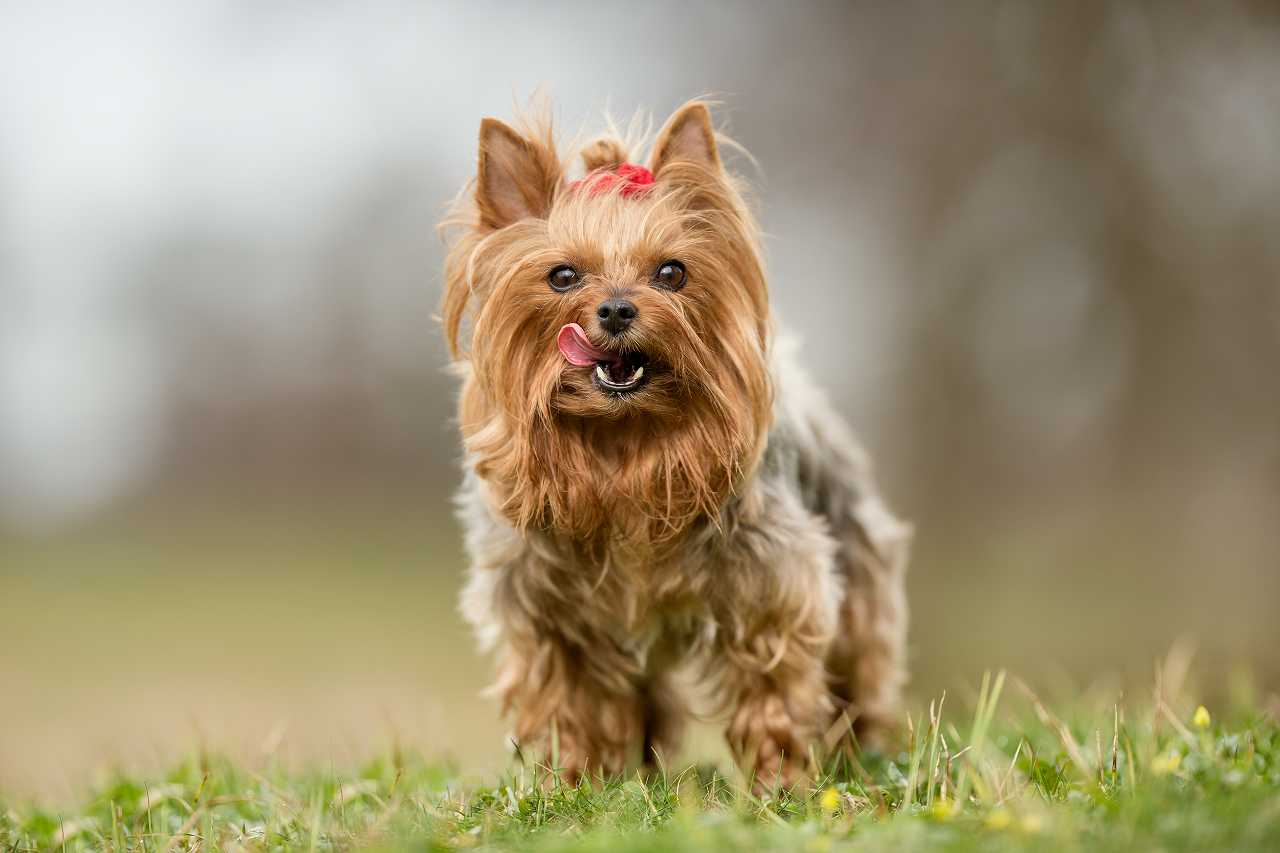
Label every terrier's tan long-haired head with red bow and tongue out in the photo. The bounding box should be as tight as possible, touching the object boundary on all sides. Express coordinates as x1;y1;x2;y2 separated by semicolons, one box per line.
444;102;769;537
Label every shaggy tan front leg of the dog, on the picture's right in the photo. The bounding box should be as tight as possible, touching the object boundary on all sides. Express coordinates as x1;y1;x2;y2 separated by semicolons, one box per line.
717;481;841;788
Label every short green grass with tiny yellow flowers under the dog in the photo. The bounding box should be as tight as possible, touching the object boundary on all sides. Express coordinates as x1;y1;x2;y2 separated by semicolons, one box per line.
0;675;1280;852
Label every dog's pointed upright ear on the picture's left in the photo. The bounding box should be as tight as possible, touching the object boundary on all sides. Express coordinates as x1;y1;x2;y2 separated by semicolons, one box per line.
476;118;561;228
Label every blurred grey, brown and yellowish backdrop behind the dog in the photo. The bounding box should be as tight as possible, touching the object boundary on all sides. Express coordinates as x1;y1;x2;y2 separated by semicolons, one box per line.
0;0;1280;797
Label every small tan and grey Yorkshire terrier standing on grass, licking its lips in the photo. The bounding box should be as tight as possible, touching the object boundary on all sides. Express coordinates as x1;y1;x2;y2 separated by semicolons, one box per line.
442;101;910;785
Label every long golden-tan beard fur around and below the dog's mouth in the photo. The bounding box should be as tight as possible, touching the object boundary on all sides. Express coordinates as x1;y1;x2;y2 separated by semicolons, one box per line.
463;308;769;544
